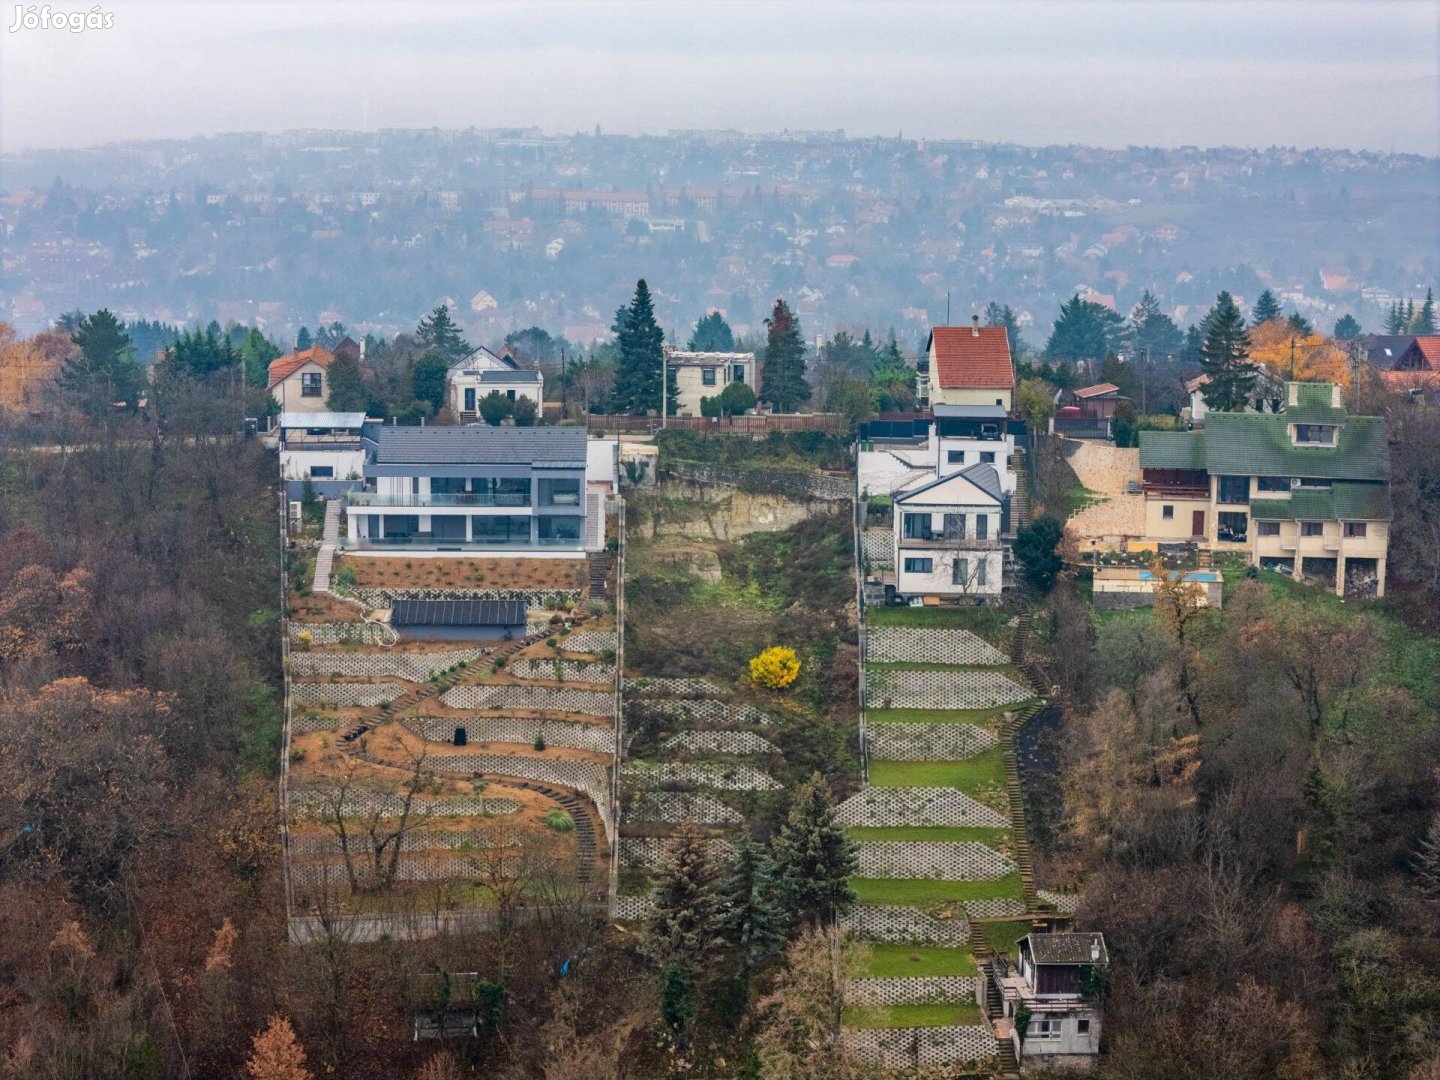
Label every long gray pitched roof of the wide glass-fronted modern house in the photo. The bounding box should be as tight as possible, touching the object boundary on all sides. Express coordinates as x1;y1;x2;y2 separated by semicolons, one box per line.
374;425;586;468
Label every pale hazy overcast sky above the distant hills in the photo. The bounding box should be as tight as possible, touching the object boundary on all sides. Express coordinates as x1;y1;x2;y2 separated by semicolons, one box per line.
8;0;1440;154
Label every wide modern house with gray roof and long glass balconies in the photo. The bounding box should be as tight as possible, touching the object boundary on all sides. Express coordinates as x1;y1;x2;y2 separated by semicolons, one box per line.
340;425;605;559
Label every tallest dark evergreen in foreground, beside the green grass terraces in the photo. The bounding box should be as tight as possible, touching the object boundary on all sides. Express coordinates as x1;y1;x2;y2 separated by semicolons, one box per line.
775;773;860;929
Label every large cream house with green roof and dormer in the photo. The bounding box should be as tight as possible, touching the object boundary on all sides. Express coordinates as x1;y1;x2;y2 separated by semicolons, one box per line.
1140;383;1392;596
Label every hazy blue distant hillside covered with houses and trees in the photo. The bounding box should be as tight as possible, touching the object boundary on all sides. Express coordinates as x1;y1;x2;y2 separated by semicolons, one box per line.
0;128;1440;354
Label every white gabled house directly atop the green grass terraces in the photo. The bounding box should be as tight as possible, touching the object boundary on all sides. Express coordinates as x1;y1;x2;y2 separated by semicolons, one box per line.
894;462;1005;599
